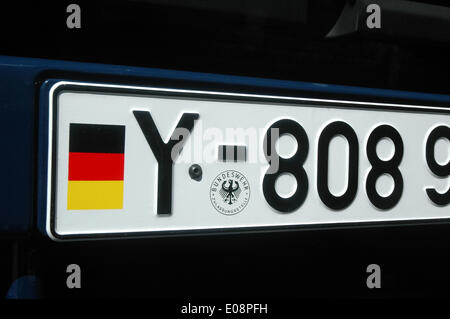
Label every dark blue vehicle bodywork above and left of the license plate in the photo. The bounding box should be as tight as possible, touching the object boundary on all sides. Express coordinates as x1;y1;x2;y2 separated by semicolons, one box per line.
0;56;450;236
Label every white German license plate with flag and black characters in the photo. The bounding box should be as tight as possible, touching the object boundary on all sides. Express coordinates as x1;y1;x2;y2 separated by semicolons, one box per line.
46;81;450;239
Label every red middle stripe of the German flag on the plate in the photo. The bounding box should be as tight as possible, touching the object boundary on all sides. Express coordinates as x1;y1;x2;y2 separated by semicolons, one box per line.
69;152;124;181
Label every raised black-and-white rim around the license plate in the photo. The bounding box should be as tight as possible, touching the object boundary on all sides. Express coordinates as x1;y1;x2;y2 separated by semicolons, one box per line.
41;80;450;240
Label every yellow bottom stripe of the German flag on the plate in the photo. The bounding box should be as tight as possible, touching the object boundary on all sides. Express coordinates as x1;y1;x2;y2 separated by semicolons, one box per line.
67;181;123;209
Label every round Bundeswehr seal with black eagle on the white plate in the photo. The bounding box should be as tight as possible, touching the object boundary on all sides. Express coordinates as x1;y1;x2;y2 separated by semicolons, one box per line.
209;170;250;215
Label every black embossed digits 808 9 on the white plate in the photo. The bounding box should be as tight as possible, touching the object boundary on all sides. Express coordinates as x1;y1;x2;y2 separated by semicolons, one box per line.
263;119;450;213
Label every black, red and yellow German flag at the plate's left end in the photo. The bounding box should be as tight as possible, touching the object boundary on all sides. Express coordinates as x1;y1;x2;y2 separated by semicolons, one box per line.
67;123;125;210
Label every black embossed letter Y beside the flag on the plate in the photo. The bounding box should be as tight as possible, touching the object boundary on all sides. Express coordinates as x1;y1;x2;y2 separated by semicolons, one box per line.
133;111;199;215
